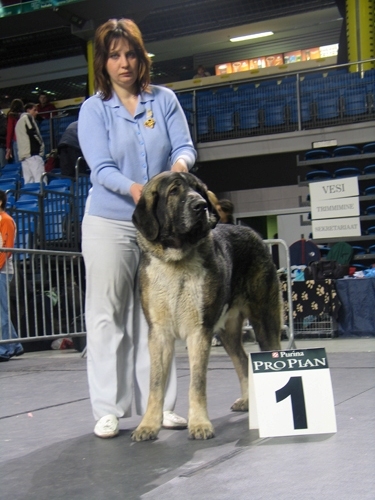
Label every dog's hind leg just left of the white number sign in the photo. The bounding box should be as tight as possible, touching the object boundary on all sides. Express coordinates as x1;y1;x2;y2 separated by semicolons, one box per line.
220;311;249;411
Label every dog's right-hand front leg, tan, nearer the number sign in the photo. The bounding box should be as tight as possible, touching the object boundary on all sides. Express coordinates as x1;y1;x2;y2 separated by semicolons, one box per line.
187;332;215;439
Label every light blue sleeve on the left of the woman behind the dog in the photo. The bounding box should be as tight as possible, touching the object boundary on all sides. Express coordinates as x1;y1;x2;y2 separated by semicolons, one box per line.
78;97;134;195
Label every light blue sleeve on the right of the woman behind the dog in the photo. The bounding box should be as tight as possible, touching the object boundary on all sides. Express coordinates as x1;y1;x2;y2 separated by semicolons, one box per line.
165;92;197;170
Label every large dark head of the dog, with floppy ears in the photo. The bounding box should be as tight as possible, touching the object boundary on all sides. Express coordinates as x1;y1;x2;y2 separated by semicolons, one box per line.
133;172;219;249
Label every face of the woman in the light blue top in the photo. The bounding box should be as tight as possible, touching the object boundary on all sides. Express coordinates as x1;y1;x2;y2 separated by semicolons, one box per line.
106;38;139;91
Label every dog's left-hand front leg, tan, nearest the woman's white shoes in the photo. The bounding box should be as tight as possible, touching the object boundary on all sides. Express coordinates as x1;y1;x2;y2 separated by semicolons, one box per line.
131;330;174;441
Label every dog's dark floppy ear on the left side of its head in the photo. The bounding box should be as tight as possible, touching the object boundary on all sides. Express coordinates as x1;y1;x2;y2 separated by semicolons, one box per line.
132;190;159;241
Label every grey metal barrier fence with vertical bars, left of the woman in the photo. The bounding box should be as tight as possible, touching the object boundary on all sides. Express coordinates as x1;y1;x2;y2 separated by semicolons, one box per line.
0;248;86;344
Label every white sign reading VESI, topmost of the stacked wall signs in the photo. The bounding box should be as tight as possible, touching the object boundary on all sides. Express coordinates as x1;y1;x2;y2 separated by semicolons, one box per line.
309;177;359;202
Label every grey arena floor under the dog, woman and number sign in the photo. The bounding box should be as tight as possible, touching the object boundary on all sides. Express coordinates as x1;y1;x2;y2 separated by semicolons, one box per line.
0;338;375;500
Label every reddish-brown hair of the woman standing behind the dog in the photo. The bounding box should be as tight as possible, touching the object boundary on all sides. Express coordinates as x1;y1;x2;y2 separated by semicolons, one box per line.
94;19;151;101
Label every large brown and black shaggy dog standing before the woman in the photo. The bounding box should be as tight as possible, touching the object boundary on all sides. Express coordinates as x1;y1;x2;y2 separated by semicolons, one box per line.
132;172;281;441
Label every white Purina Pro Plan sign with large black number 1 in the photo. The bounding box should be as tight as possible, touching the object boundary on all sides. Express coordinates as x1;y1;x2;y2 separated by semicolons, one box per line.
249;348;337;437
